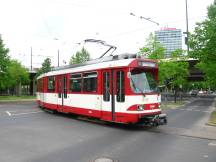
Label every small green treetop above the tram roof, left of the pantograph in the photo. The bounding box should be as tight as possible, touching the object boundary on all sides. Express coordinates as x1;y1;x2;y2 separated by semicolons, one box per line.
70;47;90;64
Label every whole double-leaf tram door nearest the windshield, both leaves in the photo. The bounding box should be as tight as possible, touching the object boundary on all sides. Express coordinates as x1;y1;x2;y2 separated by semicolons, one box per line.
102;69;125;121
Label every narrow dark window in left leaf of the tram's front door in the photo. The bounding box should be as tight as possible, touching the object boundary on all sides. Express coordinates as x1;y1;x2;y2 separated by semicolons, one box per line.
103;72;110;101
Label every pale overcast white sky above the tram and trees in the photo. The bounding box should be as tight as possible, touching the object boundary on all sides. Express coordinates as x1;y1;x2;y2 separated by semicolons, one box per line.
0;0;213;67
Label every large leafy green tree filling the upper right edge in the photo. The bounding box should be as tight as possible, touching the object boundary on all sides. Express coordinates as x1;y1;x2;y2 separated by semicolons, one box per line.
189;1;216;88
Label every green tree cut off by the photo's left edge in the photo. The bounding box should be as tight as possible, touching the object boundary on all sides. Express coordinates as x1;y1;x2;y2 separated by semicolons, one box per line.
0;36;10;89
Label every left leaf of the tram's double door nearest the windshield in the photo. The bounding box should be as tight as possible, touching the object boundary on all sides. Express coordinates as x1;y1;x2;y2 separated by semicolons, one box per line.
101;70;115;121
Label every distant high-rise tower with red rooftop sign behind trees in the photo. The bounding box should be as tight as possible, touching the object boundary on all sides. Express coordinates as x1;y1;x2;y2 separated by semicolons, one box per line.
155;27;182;58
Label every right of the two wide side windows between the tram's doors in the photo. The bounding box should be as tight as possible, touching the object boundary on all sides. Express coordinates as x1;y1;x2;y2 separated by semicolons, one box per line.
83;72;97;92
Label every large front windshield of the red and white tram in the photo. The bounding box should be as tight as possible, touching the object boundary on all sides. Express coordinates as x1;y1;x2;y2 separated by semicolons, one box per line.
130;69;158;93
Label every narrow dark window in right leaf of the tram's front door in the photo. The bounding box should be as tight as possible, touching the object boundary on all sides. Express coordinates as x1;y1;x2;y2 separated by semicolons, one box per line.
116;71;125;102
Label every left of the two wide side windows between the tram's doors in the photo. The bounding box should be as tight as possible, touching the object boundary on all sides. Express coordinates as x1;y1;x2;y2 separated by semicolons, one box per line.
70;74;82;92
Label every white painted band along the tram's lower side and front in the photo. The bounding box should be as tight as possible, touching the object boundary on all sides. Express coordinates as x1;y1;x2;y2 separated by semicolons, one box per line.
37;93;161;114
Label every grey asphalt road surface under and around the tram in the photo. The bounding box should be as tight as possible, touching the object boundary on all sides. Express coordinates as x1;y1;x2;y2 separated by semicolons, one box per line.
0;98;216;162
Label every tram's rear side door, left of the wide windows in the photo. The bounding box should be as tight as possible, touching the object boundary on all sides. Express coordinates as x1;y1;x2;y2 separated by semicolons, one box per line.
57;75;67;112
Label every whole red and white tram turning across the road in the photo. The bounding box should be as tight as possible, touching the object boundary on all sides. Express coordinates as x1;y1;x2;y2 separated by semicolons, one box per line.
37;54;167;125
